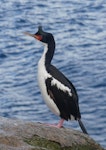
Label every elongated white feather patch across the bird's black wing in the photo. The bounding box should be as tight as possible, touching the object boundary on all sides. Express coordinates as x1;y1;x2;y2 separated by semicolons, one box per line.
51;76;72;96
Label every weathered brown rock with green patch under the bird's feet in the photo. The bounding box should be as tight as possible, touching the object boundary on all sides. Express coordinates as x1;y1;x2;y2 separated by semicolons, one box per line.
0;117;104;150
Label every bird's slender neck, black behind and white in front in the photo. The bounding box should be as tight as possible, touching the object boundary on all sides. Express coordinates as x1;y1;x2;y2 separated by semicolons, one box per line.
40;40;55;65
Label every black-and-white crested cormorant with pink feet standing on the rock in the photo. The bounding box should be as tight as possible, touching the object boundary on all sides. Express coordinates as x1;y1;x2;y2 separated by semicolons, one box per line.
24;26;88;134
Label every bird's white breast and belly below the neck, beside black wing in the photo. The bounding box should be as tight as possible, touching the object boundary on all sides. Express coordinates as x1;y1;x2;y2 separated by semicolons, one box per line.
38;60;60;116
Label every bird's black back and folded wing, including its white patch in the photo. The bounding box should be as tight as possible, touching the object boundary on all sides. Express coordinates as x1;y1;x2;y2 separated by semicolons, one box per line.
46;66;80;120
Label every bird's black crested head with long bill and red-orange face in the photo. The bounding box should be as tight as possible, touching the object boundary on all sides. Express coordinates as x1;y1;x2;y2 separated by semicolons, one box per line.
25;26;54;44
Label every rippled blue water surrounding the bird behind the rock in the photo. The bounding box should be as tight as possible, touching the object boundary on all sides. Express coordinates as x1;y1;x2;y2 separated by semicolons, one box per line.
0;0;106;147
